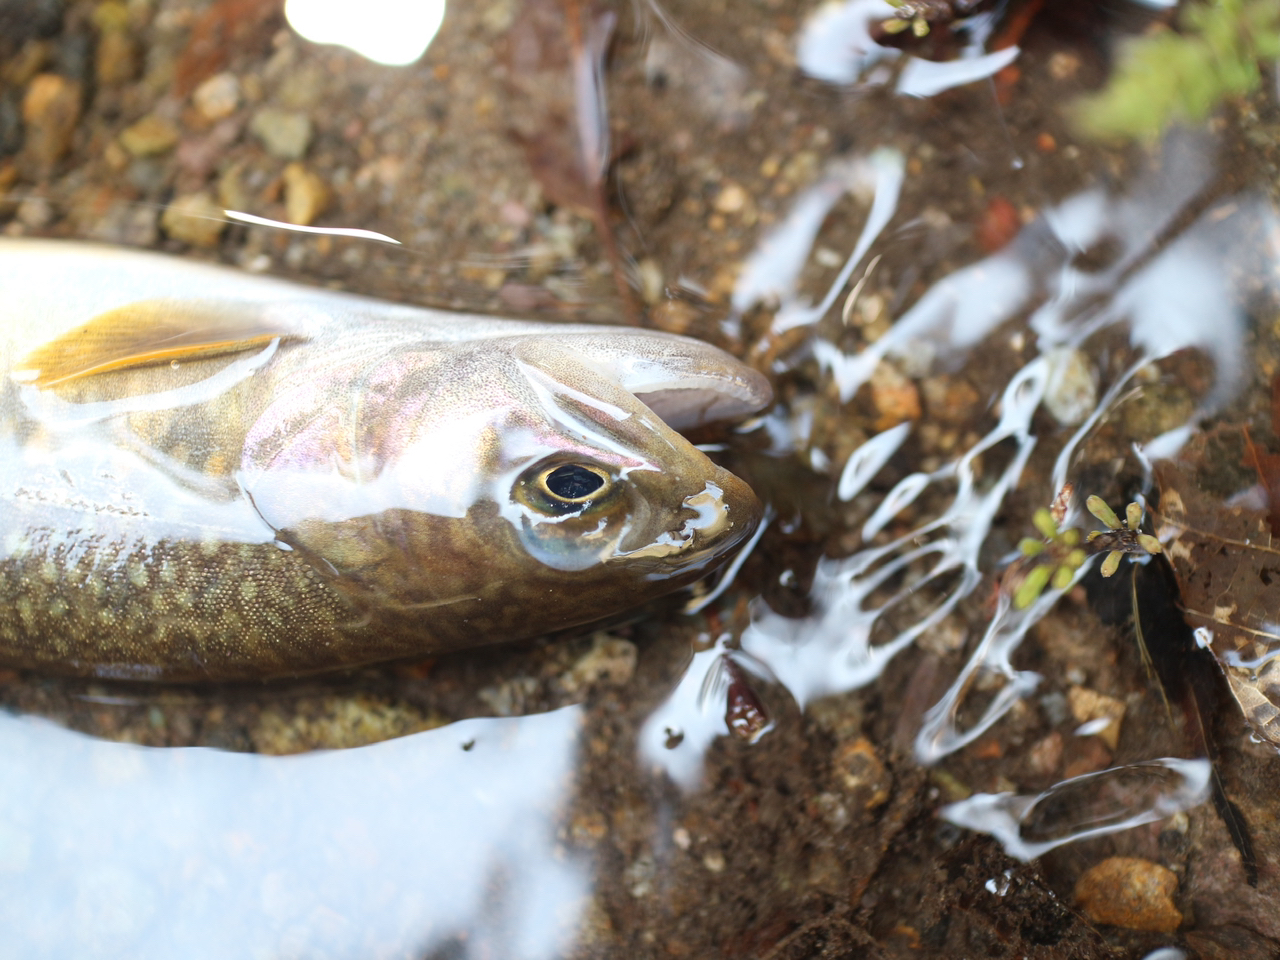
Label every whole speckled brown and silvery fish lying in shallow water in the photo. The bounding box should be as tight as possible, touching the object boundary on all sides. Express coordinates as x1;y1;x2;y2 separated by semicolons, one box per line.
0;238;771;682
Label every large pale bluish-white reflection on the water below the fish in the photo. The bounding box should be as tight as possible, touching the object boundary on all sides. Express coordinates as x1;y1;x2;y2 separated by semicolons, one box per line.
0;707;589;960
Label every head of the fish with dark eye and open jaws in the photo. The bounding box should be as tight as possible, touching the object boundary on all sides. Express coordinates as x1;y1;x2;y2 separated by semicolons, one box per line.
246;328;771;649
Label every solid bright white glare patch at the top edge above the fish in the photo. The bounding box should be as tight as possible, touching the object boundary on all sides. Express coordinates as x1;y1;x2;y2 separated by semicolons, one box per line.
284;0;444;67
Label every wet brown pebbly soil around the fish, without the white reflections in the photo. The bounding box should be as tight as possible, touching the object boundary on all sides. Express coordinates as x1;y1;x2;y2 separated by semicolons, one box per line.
0;0;1280;960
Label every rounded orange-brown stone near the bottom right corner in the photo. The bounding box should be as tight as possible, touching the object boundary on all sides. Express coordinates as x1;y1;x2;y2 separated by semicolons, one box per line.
1075;856;1183;933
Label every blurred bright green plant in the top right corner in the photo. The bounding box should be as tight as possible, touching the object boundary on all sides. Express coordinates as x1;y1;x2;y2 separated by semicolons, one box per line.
1075;0;1280;142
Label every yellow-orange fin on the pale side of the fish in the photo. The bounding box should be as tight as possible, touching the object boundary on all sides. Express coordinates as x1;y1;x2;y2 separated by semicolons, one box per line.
14;300;293;387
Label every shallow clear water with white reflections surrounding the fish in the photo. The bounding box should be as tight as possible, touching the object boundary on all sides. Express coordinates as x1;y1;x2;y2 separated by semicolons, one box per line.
0;3;1280;957
